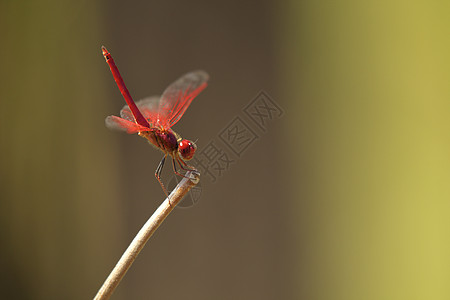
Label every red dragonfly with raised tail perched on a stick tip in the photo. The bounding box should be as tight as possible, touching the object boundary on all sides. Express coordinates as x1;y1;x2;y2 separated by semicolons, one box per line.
102;46;209;196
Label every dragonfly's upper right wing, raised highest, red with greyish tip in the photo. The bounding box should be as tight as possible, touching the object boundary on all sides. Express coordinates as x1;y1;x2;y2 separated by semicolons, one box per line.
158;71;209;127
